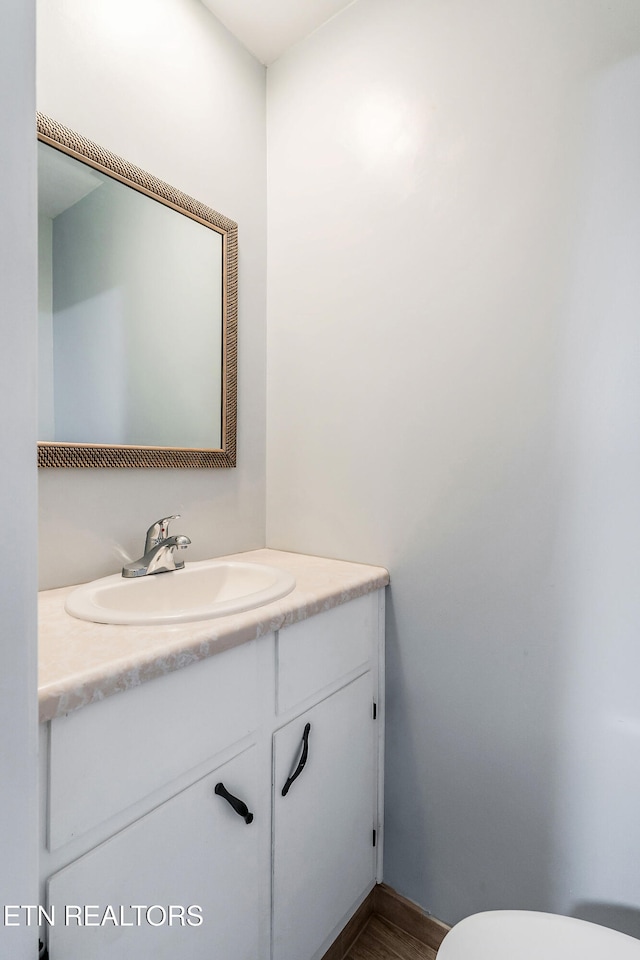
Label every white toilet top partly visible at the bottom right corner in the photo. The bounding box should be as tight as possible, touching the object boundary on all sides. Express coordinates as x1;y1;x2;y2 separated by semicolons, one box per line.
438;910;640;960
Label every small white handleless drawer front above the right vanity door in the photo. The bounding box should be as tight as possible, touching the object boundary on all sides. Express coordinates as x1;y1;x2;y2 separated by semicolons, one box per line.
277;592;379;713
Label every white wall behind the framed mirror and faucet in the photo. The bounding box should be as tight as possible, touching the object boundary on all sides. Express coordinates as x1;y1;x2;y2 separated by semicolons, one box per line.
37;0;266;588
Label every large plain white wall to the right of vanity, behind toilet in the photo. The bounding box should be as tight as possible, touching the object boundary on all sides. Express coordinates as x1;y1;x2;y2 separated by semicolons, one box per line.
267;0;640;936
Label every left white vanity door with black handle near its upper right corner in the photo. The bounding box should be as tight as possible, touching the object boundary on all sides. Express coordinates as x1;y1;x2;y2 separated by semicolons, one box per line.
48;747;262;960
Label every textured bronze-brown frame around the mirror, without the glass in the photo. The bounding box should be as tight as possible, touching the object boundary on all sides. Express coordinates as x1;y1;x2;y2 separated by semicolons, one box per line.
37;113;238;468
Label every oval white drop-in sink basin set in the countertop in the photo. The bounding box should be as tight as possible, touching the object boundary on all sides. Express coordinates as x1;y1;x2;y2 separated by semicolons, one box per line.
65;560;296;624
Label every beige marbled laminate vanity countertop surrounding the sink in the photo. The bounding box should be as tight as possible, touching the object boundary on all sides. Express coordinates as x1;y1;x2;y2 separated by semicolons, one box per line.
38;548;389;722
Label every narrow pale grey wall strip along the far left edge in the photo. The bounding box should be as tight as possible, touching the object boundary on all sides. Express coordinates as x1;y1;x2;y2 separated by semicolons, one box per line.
0;0;38;960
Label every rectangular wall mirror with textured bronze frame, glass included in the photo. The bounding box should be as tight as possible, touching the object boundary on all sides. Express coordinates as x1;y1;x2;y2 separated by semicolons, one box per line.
38;114;237;467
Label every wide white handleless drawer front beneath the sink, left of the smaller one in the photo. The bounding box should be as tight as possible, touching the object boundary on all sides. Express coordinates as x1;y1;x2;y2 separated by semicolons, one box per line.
49;641;258;850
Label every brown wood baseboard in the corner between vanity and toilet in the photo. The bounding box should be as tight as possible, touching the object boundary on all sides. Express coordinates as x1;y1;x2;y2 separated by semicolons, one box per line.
322;883;451;960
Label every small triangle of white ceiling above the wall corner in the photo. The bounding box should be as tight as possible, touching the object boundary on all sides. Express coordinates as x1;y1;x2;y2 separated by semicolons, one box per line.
202;0;354;64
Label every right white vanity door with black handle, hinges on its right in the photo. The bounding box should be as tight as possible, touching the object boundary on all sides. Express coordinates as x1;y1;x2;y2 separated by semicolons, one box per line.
273;673;376;960
